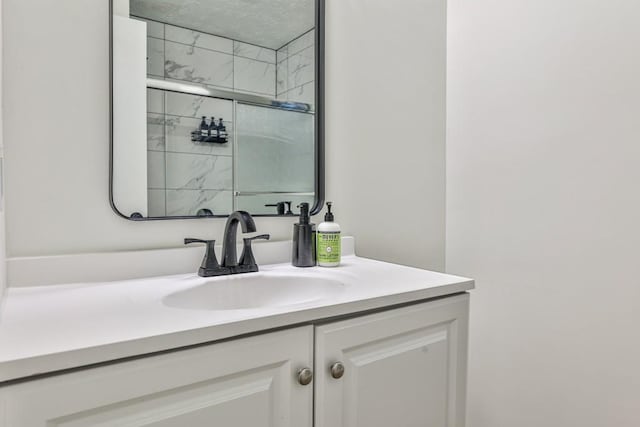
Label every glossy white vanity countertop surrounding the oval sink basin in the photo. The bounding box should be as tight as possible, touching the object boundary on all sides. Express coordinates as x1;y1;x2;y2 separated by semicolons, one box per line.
0;255;474;382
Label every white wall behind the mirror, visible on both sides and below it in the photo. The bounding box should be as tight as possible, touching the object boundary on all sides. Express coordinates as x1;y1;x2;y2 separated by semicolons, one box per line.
4;0;445;269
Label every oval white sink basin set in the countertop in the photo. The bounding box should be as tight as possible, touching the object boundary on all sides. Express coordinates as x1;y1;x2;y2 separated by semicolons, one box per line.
162;273;344;310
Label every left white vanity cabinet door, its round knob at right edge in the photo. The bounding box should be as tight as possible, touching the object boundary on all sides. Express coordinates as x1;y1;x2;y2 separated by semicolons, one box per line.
0;326;313;427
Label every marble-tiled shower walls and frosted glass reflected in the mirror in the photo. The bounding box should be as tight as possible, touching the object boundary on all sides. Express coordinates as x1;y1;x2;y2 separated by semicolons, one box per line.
113;0;317;218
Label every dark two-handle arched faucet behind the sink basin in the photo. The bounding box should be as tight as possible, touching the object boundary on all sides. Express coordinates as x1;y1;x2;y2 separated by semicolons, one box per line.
184;211;269;277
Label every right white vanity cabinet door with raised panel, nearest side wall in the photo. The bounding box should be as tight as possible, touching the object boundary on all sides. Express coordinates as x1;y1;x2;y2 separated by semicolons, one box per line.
315;294;469;427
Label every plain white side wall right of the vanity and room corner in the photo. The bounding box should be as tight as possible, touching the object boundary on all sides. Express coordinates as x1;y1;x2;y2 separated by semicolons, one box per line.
447;0;640;427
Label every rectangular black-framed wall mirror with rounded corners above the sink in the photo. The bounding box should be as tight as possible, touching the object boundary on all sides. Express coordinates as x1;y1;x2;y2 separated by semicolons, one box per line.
111;0;324;220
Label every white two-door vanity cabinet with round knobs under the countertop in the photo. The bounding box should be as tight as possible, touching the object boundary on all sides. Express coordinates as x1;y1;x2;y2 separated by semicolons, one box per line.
0;294;469;427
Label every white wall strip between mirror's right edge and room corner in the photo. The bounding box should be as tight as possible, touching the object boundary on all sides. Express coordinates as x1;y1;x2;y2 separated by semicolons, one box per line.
326;0;446;270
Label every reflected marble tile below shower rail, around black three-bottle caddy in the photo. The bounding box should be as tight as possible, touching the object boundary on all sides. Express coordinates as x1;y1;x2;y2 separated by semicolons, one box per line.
147;89;233;216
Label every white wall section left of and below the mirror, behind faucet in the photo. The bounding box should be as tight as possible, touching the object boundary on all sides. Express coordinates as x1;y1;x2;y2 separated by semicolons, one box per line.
4;0;293;257
